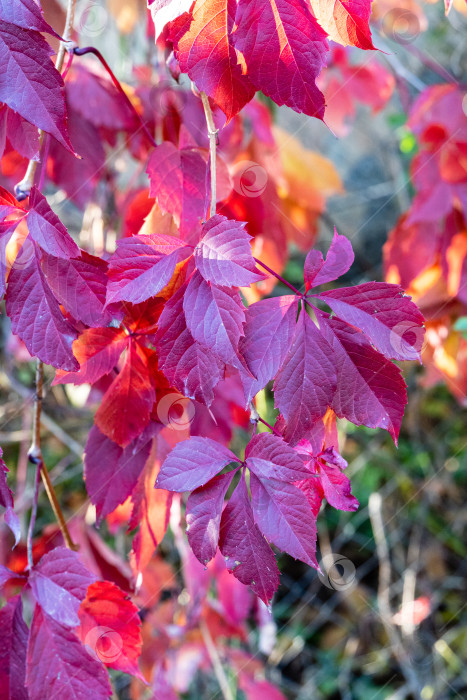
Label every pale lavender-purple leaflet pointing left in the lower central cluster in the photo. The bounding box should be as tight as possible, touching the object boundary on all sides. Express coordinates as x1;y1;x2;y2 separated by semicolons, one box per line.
156;437;239;493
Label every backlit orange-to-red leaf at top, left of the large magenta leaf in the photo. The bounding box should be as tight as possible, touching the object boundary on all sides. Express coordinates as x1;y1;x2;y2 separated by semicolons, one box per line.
174;0;255;121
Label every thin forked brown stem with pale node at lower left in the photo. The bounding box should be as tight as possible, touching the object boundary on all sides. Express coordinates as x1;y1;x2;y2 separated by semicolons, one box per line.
28;360;77;552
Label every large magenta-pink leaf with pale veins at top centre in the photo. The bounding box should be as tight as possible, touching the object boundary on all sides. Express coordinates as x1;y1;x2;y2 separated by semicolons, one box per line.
234;0;329;119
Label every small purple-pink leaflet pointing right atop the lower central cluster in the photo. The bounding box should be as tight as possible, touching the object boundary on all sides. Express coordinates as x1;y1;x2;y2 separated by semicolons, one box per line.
245;433;309;482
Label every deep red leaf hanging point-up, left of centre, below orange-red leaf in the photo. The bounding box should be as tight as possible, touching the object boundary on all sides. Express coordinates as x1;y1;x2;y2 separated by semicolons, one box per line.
94;338;156;447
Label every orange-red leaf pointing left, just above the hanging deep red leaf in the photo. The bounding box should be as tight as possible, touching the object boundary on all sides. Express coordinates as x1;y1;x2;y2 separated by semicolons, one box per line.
53;328;129;385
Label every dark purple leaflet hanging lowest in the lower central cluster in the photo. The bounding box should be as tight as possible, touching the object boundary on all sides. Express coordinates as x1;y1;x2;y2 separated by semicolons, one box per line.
219;474;279;605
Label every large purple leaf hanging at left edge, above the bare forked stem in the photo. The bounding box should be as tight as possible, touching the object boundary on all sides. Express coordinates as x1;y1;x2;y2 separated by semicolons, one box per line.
6;243;79;371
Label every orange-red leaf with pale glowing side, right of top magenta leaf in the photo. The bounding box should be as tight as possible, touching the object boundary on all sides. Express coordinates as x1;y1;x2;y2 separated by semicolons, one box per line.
311;0;375;49
